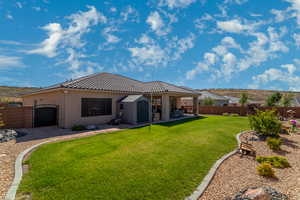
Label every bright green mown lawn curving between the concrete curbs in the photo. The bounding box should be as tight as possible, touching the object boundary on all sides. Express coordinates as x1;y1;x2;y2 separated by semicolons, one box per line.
18;116;248;200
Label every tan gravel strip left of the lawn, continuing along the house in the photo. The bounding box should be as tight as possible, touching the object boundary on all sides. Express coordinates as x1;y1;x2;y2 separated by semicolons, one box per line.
0;125;128;200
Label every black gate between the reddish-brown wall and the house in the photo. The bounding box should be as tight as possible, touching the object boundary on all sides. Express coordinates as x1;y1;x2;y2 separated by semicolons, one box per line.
34;105;57;127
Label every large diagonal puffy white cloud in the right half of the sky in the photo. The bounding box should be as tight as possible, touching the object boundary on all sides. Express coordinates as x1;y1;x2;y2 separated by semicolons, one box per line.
186;27;292;81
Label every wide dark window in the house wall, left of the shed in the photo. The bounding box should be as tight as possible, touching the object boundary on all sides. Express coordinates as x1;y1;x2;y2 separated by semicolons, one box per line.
81;98;112;117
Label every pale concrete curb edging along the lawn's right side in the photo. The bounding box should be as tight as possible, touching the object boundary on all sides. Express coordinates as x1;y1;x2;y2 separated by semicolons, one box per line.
185;131;249;200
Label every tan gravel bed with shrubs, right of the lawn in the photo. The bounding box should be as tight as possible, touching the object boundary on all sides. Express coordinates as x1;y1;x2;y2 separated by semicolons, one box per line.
199;126;300;200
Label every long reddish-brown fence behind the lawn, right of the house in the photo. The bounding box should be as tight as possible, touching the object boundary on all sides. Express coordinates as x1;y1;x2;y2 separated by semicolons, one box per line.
199;106;300;118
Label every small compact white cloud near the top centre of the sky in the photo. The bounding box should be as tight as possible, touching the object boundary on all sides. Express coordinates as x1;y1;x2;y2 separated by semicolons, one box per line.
146;11;168;35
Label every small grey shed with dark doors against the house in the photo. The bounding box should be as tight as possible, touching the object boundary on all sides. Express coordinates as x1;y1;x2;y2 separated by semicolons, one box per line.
119;95;151;124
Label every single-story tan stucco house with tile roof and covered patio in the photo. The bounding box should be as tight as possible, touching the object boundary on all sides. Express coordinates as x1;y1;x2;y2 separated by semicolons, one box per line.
22;73;200;128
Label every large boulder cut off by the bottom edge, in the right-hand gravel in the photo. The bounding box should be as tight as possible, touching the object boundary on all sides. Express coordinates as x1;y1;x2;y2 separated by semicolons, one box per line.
232;187;288;200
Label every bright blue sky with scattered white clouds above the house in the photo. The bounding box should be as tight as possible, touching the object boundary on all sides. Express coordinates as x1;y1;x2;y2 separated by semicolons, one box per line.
0;0;300;91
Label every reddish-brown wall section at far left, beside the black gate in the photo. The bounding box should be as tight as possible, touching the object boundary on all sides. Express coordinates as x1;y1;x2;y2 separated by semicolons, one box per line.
0;105;33;128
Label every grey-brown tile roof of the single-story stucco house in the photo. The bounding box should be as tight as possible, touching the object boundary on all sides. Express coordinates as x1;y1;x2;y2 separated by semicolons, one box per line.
26;73;199;94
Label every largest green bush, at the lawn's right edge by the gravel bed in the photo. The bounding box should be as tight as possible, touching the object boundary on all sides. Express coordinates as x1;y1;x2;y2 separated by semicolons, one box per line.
248;110;281;137
